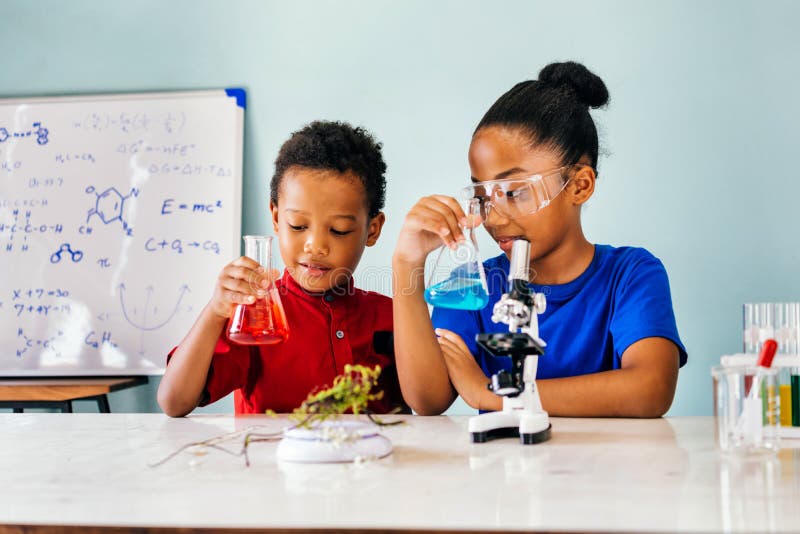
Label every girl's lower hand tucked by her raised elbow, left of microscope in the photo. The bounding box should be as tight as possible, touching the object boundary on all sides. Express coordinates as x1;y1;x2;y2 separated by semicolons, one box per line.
435;328;497;410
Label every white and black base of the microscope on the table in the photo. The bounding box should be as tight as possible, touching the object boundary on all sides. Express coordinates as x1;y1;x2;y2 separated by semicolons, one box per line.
469;411;553;445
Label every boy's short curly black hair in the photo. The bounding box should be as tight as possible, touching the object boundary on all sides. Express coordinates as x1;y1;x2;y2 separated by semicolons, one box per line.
270;121;386;218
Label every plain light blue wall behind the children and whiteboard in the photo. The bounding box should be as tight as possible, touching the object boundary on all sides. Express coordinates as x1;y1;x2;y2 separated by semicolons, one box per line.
0;0;800;415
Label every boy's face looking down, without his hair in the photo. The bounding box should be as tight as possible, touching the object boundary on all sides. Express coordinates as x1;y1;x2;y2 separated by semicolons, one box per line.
270;166;384;293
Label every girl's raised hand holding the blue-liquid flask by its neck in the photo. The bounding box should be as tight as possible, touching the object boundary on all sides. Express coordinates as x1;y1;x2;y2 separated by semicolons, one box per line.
394;195;466;265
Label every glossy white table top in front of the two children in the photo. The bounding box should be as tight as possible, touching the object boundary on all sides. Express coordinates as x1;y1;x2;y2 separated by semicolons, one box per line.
0;413;800;532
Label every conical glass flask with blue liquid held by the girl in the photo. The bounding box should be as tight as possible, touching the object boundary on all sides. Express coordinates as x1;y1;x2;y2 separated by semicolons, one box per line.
425;198;489;310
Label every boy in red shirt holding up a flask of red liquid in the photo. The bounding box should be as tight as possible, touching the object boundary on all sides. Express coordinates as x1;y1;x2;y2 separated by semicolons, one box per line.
158;121;405;417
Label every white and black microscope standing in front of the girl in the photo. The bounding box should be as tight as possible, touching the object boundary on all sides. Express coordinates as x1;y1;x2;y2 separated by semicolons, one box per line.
469;239;552;445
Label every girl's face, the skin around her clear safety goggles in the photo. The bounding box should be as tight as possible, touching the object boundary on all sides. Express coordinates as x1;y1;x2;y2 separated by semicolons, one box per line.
469;126;594;261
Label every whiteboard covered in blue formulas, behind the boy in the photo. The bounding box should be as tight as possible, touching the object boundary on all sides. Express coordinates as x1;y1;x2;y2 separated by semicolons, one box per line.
0;89;244;376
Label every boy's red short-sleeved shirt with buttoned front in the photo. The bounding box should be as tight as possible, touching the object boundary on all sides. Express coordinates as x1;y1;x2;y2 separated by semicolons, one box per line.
186;271;404;414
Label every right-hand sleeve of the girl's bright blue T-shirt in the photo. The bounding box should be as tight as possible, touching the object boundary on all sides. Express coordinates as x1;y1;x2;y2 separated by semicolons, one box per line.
611;254;687;366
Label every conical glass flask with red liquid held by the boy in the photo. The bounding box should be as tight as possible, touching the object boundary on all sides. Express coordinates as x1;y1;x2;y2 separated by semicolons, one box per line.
228;235;289;345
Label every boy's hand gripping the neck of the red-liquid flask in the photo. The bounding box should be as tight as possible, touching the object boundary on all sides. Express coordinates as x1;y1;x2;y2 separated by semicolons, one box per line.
209;256;280;319
